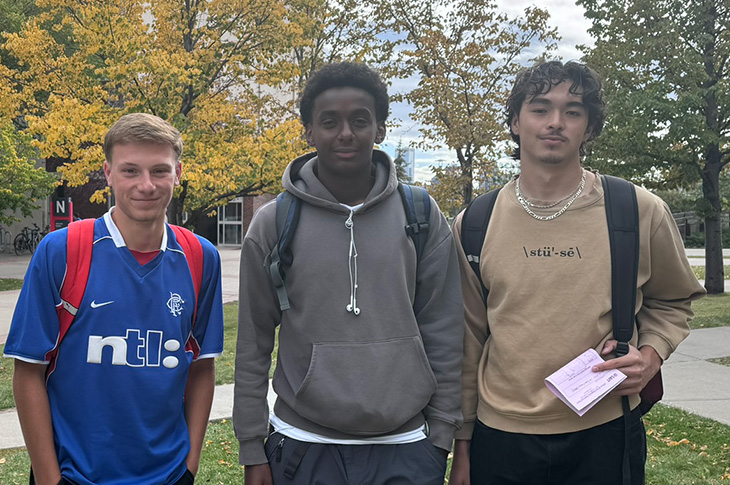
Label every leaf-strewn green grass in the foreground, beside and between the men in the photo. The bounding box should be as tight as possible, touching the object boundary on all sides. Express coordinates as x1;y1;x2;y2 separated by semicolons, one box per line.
0;404;730;485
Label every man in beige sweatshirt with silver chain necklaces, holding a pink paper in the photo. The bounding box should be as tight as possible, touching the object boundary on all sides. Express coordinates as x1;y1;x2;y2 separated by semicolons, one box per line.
450;61;704;485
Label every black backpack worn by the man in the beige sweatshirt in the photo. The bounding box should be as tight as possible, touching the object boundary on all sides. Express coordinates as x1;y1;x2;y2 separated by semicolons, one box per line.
461;175;663;484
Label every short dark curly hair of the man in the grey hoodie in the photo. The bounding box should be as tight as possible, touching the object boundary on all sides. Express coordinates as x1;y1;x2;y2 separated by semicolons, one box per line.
299;62;389;126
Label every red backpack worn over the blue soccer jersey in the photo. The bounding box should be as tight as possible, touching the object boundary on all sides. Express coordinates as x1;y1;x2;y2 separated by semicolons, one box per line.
46;219;203;378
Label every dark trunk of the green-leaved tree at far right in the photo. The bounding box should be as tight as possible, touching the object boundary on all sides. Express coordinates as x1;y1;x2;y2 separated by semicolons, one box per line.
702;144;725;294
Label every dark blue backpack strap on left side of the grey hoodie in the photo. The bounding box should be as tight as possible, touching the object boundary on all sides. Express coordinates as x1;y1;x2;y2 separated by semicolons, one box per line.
264;192;302;311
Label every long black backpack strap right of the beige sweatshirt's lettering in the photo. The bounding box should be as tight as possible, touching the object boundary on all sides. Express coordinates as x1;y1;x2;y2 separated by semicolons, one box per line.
601;175;639;485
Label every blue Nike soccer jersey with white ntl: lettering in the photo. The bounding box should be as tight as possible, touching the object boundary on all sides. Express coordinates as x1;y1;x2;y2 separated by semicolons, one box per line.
5;212;223;485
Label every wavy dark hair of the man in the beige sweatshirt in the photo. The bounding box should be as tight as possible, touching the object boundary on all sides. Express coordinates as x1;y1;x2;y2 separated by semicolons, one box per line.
507;61;606;159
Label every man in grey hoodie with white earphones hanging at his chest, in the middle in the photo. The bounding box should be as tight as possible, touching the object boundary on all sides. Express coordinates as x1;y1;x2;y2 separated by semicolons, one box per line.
233;63;464;485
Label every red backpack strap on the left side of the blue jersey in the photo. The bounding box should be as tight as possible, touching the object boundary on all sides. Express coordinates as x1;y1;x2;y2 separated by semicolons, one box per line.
46;219;96;376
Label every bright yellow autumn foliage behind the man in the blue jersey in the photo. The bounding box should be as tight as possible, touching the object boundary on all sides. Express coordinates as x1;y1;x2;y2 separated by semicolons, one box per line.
0;0;309;223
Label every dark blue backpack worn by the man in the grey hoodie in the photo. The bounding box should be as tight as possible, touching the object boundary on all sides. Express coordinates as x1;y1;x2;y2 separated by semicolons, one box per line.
264;183;431;311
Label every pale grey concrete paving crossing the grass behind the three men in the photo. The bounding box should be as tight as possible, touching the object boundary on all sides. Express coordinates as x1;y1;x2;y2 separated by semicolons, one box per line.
0;248;730;449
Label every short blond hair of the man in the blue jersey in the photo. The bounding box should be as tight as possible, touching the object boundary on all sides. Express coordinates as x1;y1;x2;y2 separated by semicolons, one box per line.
104;113;182;163
